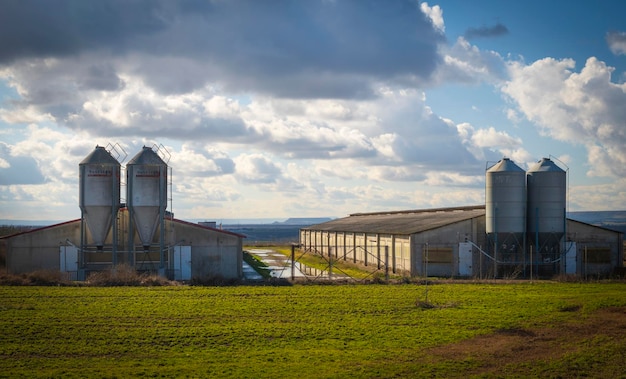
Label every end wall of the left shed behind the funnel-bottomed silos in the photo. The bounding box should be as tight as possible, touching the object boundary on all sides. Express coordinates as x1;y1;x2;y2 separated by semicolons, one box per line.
0;217;243;279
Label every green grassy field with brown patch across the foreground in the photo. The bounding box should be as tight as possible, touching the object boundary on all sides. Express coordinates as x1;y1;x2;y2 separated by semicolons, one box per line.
0;282;626;378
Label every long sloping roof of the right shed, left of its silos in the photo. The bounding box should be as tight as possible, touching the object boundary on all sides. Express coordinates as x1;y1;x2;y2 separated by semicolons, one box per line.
303;205;485;235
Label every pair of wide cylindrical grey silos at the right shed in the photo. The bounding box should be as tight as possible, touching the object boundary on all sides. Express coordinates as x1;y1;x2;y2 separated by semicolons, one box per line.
485;158;567;275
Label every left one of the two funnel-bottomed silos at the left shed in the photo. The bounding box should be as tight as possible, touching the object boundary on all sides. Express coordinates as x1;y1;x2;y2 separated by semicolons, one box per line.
78;146;121;251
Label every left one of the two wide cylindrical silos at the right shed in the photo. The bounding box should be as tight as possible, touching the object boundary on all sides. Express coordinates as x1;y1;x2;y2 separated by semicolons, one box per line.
485;158;526;275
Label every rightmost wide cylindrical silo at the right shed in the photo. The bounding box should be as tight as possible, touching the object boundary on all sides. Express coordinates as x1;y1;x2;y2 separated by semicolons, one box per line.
526;158;567;275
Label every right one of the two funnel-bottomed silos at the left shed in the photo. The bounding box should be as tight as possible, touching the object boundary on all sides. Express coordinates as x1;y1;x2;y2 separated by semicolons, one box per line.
126;146;167;270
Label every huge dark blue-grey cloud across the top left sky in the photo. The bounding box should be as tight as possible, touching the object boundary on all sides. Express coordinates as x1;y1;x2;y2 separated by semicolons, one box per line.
0;0;444;98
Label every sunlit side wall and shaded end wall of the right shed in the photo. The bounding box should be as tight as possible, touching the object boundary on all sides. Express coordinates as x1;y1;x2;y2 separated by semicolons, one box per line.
300;216;624;278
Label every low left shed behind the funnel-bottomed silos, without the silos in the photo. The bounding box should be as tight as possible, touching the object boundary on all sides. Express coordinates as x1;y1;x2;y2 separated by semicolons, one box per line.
0;208;245;280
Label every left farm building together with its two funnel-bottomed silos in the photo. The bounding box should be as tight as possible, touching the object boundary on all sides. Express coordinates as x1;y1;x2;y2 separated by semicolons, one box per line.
0;146;245;280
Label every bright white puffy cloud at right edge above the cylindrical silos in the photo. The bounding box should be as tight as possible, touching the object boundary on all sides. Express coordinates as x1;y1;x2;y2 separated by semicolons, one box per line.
502;57;626;177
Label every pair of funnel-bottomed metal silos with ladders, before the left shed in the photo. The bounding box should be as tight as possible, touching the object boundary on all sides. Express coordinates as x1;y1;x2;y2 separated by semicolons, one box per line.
79;146;168;266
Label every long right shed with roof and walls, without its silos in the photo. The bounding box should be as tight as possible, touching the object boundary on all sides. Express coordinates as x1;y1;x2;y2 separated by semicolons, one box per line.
300;205;623;277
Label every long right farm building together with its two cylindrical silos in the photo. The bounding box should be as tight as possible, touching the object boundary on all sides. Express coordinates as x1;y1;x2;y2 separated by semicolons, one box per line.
300;158;624;278
